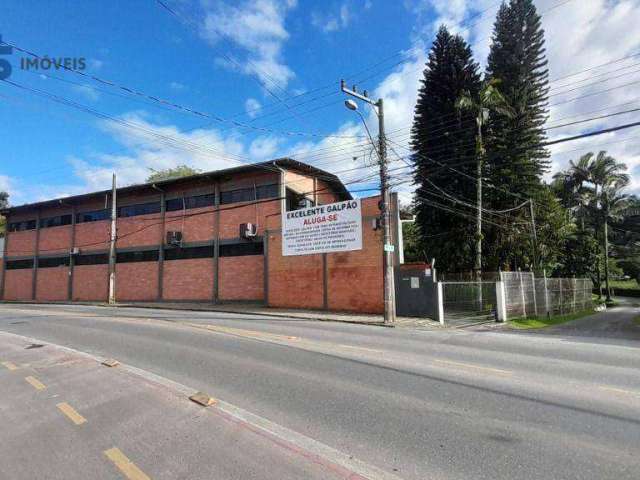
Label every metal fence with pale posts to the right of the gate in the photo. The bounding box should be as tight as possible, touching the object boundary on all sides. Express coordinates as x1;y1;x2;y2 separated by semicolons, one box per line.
500;272;593;318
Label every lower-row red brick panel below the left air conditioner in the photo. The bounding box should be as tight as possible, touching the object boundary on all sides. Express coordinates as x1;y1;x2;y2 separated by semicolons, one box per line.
162;258;213;300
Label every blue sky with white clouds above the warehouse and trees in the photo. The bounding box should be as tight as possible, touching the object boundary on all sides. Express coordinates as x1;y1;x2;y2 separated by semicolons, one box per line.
0;0;640;205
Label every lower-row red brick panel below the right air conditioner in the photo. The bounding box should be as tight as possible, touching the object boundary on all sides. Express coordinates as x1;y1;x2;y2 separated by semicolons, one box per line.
218;255;264;300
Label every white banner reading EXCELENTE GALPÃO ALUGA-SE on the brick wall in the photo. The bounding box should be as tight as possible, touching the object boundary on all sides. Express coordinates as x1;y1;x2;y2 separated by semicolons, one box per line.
282;199;362;256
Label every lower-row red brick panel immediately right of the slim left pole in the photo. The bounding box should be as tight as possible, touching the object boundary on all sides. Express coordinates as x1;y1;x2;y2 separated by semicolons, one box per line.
116;262;158;302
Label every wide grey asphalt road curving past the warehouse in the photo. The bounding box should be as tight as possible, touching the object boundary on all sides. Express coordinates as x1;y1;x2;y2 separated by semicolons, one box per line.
0;305;640;480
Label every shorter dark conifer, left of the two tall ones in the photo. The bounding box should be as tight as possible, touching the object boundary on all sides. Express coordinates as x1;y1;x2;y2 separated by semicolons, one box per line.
411;26;480;271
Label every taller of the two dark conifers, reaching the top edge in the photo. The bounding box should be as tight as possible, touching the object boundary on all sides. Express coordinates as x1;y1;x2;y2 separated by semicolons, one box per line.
485;0;549;268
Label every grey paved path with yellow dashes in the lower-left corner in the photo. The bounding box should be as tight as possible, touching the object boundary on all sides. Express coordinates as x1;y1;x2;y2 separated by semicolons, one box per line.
0;332;399;480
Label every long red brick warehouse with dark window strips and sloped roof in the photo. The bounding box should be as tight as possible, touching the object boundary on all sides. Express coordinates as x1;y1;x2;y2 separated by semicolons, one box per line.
0;159;397;313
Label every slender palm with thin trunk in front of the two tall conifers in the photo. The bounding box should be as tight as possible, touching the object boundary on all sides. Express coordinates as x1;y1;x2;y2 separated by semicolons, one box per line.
456;79;513;281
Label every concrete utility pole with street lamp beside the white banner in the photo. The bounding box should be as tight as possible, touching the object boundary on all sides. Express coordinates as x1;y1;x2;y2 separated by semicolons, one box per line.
340;80;396;324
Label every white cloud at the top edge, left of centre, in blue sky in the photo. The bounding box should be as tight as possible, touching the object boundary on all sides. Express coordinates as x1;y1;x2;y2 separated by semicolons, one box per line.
203;0;296;88
